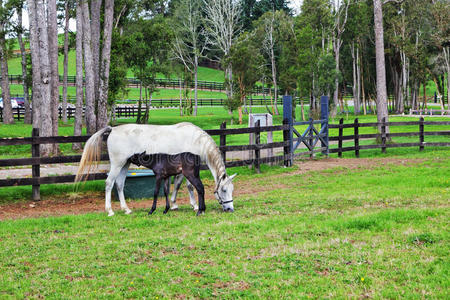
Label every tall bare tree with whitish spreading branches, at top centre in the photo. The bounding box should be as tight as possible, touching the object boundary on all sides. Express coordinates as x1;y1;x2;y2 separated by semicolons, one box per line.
203;0;241;108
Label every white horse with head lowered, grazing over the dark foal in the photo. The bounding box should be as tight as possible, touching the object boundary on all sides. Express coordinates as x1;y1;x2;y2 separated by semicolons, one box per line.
75;122;236;216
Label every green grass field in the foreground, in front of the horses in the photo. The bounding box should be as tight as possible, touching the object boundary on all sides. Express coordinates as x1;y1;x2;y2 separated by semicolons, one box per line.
0;150;450;299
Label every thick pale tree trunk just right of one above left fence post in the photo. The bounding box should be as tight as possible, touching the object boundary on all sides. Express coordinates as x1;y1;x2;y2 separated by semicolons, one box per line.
47;0;59;154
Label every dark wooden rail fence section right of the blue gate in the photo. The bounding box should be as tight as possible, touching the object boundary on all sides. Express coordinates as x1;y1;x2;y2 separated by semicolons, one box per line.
329;118;450;157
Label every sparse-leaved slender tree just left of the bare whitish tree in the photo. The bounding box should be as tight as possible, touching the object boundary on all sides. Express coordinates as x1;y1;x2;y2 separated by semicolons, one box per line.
172;0;209;116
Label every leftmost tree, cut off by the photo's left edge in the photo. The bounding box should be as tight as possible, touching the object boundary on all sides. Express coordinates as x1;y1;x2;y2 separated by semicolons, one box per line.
0;0;14;124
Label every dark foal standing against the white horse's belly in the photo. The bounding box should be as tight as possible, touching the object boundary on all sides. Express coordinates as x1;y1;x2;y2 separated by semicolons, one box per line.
130;152;206;216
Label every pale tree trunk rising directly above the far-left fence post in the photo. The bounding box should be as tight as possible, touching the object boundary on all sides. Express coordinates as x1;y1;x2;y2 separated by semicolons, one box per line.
28;0;42;128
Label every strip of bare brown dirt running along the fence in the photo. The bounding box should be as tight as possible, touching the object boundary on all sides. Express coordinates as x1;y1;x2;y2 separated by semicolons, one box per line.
0;158;422;220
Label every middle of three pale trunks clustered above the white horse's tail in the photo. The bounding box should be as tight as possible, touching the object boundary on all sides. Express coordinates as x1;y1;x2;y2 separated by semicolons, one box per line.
82;0;97;134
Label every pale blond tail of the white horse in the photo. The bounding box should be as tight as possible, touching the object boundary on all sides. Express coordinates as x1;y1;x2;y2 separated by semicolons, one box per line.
75;126;112;182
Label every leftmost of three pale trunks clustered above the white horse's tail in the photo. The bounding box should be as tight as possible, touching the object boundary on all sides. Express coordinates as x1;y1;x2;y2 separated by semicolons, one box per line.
72;0;83;150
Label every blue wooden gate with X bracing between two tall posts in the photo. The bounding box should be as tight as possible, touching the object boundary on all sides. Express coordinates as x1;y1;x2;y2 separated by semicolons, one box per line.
283;96;328;166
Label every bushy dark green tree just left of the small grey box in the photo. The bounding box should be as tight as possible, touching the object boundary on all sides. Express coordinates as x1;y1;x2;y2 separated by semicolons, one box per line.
225;33;263;124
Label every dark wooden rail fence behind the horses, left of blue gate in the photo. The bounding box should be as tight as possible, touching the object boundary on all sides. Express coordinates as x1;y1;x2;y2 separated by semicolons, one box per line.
0;123;290;201
